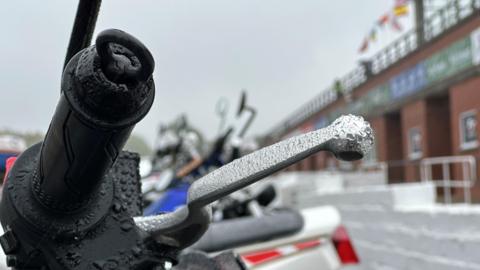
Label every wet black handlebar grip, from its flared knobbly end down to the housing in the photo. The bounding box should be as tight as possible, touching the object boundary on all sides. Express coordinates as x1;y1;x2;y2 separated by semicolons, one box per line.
33;29;155;212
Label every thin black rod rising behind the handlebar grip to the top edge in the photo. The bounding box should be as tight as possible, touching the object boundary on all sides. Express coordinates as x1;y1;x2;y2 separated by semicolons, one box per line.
63;0;102;68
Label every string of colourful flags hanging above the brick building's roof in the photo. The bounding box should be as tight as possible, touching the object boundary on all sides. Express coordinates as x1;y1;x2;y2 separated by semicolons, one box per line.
359;0;410;53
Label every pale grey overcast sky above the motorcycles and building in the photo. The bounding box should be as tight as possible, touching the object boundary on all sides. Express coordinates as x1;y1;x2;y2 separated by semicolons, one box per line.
0;0;411;146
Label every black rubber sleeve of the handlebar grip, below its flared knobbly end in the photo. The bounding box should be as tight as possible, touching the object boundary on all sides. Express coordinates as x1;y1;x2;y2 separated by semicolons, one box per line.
35;94;133;211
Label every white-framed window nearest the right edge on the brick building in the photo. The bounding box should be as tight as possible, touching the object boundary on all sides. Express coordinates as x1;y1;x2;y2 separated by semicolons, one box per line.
460;110;478;150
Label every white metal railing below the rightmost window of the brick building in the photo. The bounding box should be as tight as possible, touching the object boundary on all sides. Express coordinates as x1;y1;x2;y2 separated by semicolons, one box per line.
420;156;477;204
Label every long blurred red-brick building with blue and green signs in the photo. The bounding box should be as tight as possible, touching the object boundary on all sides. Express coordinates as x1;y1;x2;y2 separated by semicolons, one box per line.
267;0;480;199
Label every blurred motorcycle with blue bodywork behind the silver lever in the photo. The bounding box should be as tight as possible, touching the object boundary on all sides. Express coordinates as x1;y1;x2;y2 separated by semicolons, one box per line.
142;89;256;216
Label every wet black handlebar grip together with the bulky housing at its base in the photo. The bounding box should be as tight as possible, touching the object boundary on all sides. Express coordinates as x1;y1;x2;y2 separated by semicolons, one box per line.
0;30;171;269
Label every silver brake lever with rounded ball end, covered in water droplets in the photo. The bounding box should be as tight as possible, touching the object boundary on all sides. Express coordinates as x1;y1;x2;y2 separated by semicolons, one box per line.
135;115;373;248
